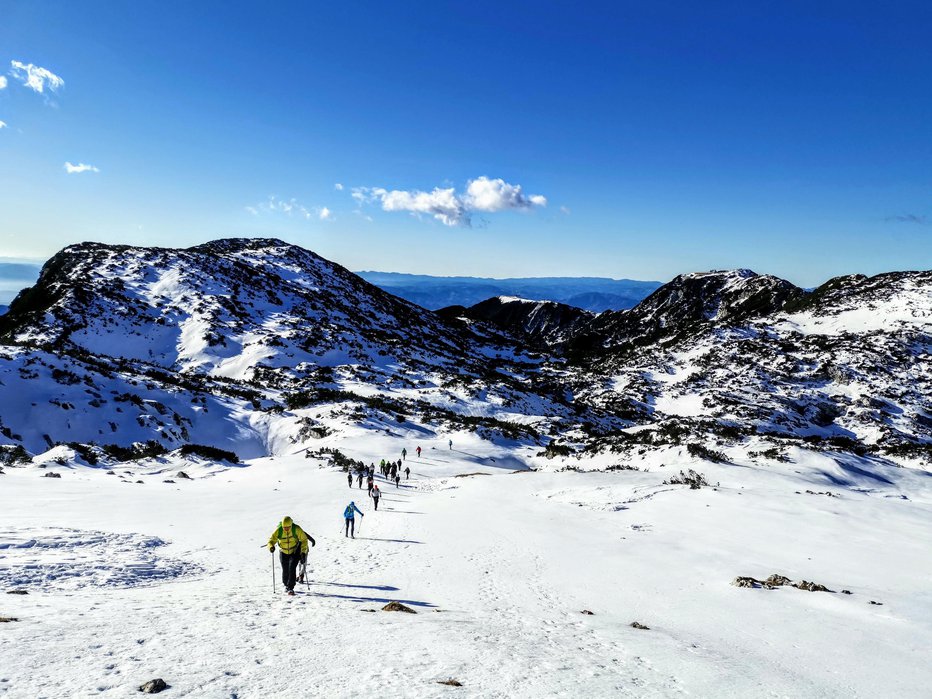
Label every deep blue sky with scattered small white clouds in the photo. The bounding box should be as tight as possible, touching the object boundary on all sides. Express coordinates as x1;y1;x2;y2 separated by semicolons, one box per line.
0;0;932;286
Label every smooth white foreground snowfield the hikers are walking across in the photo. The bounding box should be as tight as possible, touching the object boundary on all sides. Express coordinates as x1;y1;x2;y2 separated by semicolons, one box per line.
0;432;932;698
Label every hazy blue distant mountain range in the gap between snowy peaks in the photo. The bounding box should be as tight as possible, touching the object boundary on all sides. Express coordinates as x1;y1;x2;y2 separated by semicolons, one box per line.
357;272;661;313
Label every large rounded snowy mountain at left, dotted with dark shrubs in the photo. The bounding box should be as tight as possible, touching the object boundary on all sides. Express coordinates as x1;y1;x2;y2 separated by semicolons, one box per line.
0;239;569;455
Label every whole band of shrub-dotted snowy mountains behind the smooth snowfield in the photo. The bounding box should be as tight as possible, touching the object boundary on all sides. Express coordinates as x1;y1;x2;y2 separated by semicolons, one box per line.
0;239;932;474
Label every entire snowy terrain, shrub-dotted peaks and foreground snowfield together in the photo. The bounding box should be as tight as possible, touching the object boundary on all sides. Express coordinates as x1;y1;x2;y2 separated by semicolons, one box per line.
0;240;932;697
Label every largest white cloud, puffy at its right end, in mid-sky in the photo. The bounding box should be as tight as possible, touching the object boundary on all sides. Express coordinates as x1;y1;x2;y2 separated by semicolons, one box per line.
351;176;547;227
